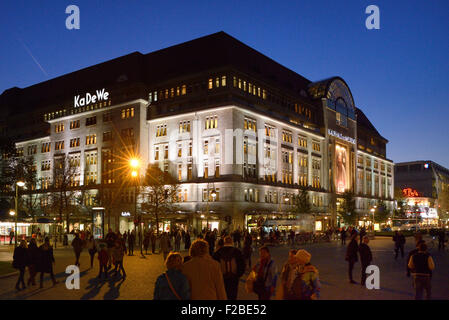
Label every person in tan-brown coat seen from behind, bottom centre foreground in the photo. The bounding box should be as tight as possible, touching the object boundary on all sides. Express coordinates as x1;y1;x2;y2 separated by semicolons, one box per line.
182;239;227;300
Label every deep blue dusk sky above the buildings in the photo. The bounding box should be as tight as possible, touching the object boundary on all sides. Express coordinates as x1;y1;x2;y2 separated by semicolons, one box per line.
0;0;449;168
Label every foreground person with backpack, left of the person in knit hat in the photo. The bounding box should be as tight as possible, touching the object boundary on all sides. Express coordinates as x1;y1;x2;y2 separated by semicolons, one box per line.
252;246;277;300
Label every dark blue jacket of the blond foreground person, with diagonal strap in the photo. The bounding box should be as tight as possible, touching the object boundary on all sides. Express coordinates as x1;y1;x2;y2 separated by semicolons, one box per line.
153;269;190;300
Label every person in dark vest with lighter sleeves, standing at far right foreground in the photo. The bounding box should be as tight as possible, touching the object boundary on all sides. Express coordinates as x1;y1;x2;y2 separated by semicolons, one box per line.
408;243;435;300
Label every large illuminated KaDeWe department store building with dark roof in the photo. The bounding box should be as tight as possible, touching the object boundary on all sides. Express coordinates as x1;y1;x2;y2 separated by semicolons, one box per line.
0;32;393;231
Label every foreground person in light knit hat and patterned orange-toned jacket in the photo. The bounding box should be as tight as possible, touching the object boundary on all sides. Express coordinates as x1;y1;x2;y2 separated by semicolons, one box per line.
288;249;321;300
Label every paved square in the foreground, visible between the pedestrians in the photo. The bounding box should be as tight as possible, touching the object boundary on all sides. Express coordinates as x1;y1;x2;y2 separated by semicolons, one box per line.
0;237;449;300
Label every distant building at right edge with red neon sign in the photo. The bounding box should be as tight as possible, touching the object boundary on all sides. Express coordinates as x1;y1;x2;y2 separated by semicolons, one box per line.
394;161;449;225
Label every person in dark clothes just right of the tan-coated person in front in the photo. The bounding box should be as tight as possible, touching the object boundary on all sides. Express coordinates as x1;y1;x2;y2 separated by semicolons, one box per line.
212;236;245;300
